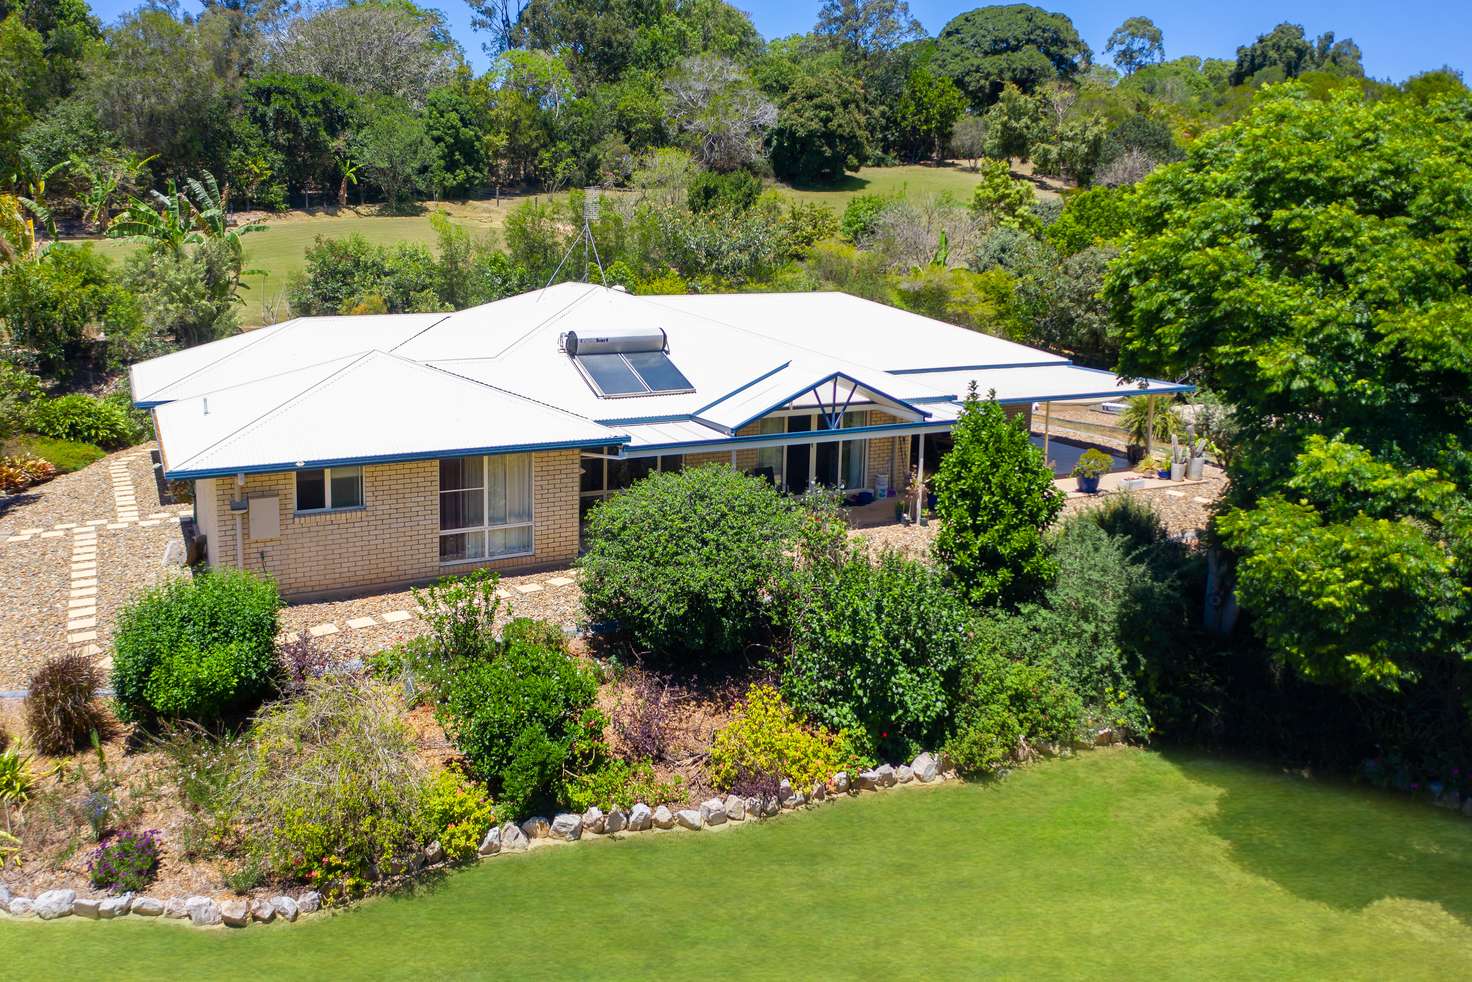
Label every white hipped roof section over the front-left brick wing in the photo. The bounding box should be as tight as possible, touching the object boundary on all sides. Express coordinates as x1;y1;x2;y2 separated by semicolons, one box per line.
158;350;629;478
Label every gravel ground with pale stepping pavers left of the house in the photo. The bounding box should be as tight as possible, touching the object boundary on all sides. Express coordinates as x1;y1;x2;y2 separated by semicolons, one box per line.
0;443;191;690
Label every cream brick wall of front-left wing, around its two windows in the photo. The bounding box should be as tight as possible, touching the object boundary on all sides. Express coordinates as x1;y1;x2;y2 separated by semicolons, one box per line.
206;451;578;598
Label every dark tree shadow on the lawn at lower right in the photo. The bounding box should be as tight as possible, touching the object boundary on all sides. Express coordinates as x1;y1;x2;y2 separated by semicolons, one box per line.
1166;752;1472;925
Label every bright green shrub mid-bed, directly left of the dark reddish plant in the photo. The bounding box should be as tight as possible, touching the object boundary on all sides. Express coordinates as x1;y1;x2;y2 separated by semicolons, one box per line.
436;636;602;819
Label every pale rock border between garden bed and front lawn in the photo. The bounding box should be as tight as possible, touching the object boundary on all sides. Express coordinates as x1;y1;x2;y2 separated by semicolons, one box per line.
0;752;957;929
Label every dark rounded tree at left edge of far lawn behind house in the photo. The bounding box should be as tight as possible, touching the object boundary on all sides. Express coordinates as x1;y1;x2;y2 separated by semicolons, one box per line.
771;75;866;181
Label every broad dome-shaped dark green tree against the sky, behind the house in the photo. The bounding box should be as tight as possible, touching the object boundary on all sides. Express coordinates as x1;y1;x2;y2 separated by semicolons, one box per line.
936;3;1089;109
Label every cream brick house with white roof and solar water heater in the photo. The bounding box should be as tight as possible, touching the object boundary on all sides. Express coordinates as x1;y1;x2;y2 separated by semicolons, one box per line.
131;283;1186;598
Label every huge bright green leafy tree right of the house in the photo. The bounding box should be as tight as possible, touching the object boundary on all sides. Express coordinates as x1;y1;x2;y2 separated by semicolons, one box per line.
1105;85;1472;701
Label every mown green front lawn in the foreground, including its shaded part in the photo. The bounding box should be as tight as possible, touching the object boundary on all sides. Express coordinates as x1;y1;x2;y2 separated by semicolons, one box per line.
0;751;1472;981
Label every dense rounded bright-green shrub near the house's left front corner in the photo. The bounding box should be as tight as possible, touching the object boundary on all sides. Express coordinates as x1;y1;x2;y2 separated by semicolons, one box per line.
112;570;281;724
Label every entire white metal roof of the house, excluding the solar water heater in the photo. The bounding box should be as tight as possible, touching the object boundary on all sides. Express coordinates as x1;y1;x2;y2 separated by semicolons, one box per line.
131;283;1188;477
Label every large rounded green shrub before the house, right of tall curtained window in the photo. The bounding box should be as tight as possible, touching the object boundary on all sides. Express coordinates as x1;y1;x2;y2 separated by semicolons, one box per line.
578;464;799;658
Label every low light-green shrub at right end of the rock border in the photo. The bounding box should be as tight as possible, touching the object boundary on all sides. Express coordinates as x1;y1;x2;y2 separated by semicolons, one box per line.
945;652;1082;773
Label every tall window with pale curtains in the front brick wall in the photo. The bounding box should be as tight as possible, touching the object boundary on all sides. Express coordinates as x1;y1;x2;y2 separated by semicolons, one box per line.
440;453;531;562
